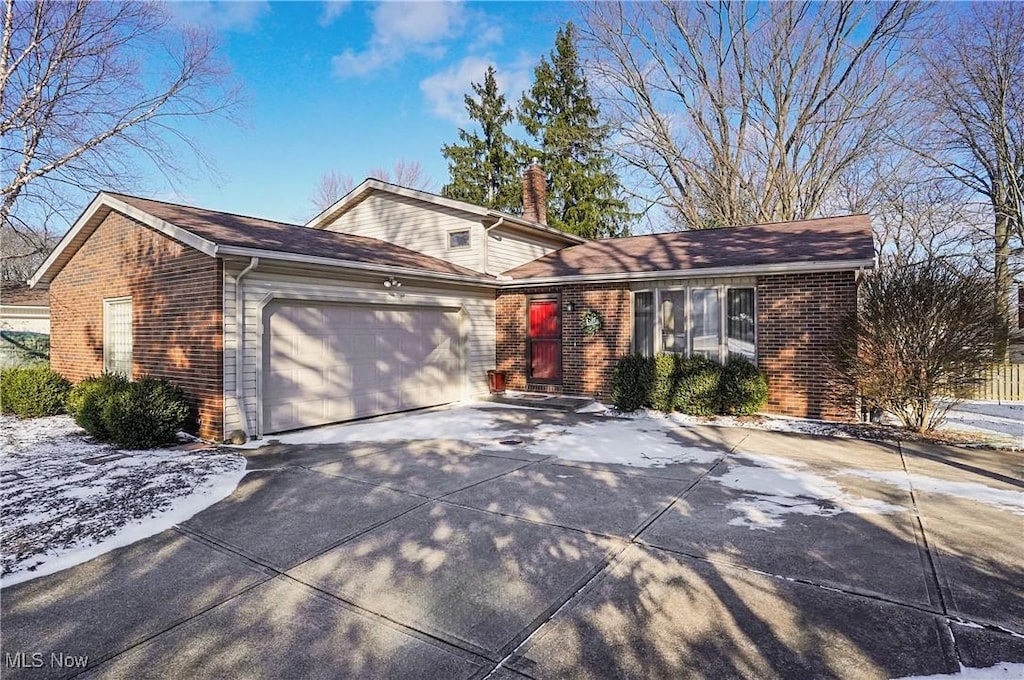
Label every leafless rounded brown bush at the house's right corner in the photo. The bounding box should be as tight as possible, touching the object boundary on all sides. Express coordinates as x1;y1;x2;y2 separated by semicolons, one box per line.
831;260;994;432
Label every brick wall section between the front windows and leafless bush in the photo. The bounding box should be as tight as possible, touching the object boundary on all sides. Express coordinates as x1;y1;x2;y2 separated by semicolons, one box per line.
758;271;857;420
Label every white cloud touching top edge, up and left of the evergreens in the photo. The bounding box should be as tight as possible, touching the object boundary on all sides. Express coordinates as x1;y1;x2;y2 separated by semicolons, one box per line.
332;2;466;77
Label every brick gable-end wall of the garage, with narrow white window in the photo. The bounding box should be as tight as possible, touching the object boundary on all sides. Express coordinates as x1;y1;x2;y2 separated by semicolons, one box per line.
50;213;223;439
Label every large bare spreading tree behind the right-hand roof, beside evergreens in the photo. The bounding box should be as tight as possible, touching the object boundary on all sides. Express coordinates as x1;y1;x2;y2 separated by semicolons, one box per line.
582;0;923;228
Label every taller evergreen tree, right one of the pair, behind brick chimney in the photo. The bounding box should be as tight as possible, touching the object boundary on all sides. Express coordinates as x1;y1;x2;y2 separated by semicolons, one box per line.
518;22;633;239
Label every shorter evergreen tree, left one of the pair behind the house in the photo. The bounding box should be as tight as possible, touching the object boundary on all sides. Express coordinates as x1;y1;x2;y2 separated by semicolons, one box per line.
441;67;522;213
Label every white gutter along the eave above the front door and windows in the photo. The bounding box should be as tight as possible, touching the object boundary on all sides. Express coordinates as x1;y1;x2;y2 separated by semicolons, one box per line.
501;257;874;288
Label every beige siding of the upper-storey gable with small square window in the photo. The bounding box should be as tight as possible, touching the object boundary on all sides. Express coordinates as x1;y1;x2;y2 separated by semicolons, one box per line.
324;193;483;271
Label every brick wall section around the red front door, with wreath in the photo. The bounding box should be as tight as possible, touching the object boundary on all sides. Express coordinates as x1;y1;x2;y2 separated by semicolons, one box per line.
495;284;632;399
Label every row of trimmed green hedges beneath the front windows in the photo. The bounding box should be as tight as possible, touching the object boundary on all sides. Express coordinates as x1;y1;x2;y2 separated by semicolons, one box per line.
611;353;768;416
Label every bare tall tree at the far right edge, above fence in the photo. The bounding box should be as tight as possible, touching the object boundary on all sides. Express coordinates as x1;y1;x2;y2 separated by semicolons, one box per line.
919;2;1024;356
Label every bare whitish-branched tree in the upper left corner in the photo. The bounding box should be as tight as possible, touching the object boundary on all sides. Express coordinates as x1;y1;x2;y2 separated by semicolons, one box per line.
0;0;240;276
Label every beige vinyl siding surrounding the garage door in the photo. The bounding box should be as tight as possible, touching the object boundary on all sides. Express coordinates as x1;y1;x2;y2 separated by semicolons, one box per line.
223;263;495;436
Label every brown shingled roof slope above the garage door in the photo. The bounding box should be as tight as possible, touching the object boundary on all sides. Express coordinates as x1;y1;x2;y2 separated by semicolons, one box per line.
108;193;483;278
